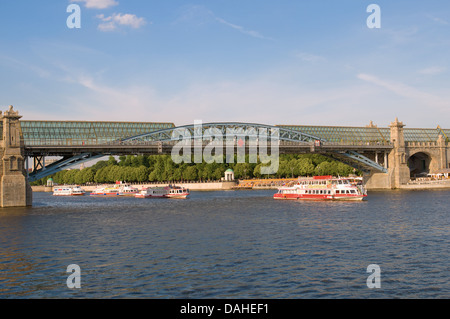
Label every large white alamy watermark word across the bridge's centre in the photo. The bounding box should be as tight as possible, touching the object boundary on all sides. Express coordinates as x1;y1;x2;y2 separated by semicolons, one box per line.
171;120;280;175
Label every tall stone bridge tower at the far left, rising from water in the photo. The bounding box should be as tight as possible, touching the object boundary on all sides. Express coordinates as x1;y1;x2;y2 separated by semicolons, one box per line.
0;106;32;207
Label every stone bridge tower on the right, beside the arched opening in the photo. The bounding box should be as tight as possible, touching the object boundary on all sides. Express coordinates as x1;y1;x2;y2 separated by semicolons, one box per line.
388;118;410;188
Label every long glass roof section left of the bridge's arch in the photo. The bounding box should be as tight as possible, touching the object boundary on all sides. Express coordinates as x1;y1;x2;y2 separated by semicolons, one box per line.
20;121;175;146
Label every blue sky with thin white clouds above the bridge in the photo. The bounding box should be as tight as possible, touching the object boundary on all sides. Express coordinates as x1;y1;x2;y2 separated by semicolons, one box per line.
0;0;450;128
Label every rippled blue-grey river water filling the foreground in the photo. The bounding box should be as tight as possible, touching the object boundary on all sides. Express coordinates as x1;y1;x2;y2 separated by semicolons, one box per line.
0;190;450;299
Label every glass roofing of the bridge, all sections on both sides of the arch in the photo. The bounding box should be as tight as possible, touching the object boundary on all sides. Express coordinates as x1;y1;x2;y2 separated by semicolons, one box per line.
16;121;450;146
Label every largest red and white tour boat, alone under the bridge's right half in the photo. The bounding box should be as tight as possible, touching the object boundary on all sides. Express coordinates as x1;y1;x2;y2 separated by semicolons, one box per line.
273;176;367;200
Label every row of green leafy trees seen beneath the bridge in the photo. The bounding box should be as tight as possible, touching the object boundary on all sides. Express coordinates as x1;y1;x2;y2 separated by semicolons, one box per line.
32;154;359;185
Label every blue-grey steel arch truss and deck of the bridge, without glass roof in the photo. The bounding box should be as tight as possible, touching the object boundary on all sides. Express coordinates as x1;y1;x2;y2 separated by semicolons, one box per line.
25;122;392;181
